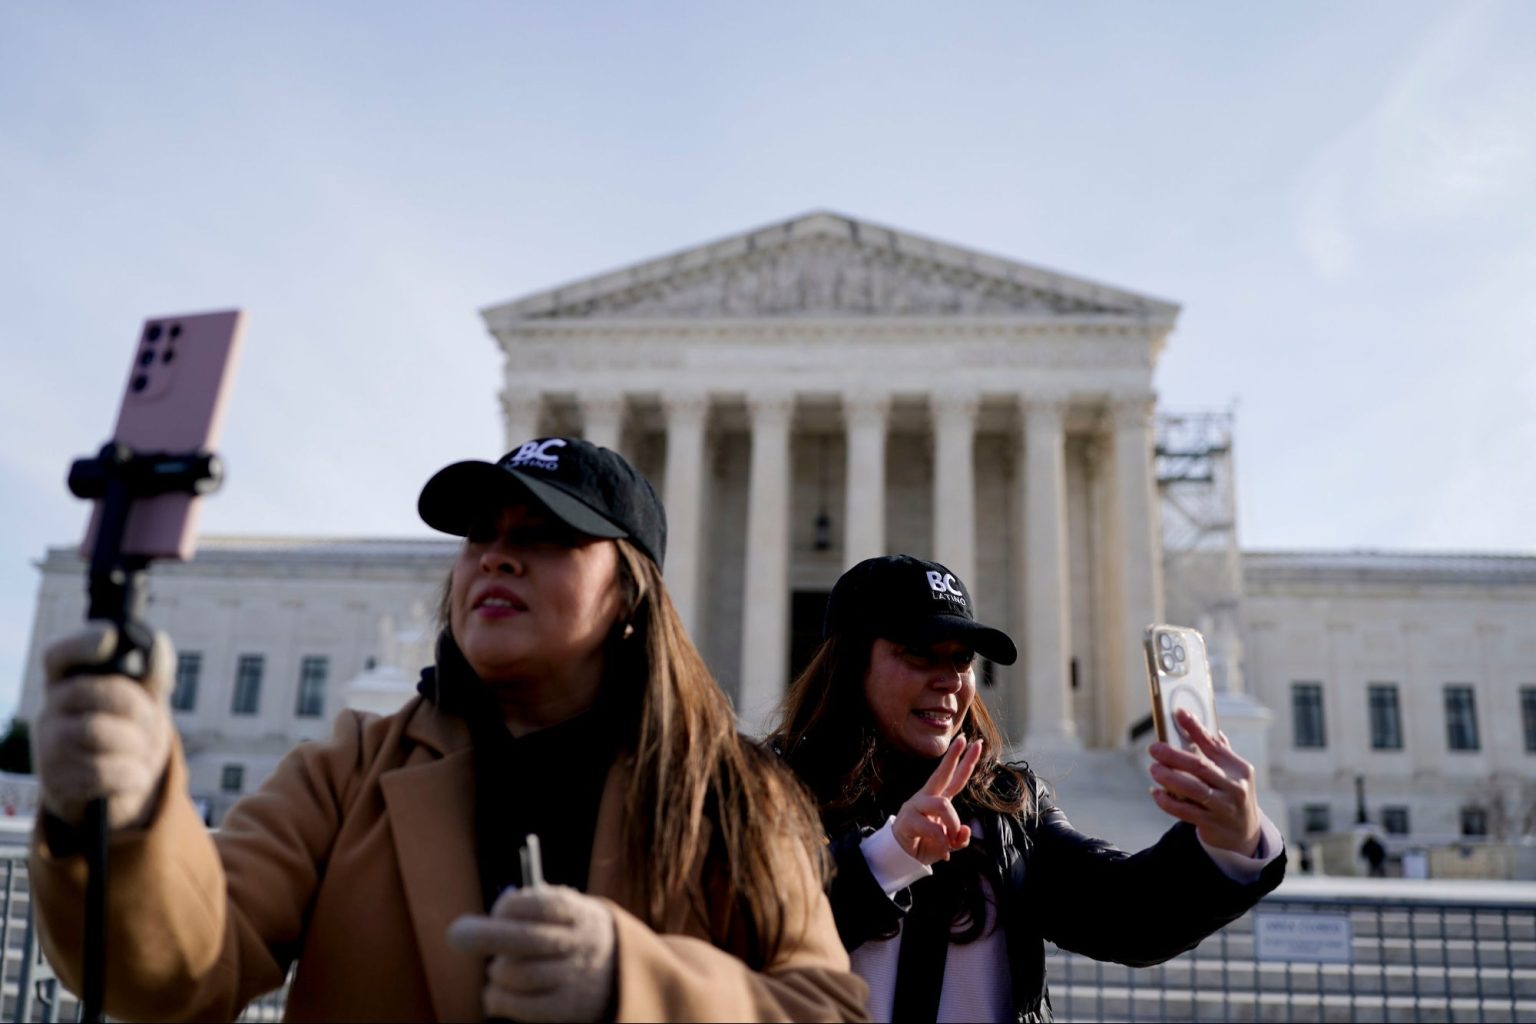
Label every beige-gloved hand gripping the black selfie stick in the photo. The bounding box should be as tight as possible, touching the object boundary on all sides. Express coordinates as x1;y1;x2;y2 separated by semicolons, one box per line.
34;622;177;829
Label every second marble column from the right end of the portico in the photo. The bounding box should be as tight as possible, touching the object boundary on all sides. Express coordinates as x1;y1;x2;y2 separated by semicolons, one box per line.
1018;401;1080;754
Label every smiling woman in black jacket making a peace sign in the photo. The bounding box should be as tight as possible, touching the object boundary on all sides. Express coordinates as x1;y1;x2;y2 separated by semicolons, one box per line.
771;556;1284;1024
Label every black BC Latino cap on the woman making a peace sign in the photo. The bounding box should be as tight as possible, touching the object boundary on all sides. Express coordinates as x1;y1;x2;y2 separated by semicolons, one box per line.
822;554;1018;665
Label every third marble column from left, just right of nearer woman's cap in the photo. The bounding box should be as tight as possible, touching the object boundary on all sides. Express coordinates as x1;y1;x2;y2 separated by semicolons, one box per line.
662;395;710;637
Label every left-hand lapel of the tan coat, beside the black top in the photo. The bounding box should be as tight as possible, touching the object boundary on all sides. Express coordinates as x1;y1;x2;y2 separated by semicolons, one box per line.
378;748;485;1021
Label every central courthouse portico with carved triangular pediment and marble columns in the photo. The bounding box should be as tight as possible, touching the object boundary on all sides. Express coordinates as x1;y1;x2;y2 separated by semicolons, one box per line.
484;213;1178;749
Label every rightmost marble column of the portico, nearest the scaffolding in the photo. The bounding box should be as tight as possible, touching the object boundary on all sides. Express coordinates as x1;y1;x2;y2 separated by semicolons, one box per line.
1107;396;1163;746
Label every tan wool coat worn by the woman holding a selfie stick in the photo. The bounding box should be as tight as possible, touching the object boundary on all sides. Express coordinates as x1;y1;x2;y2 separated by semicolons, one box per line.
31;699;868;1021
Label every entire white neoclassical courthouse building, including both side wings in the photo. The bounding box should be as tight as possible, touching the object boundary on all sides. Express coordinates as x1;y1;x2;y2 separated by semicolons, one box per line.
20;212;1536;841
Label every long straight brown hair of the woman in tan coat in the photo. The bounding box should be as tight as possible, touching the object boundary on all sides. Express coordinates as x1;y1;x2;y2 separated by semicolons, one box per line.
439;539;826;967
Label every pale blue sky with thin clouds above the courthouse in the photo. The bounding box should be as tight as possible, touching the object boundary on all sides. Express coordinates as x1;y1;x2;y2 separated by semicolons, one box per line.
0;0;1536;712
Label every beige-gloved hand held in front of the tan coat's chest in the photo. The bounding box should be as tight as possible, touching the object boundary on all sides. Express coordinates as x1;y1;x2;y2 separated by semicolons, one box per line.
449;886;614;1021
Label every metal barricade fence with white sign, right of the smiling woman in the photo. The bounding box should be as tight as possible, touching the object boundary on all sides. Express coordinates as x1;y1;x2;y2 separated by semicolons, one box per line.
1046;878;1536;1021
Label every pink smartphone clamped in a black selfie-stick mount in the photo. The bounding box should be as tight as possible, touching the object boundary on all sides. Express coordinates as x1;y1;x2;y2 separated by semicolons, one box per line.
80;310;246;560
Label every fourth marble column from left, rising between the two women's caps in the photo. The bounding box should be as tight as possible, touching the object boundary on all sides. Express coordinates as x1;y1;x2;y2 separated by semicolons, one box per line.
736;393;794;735
